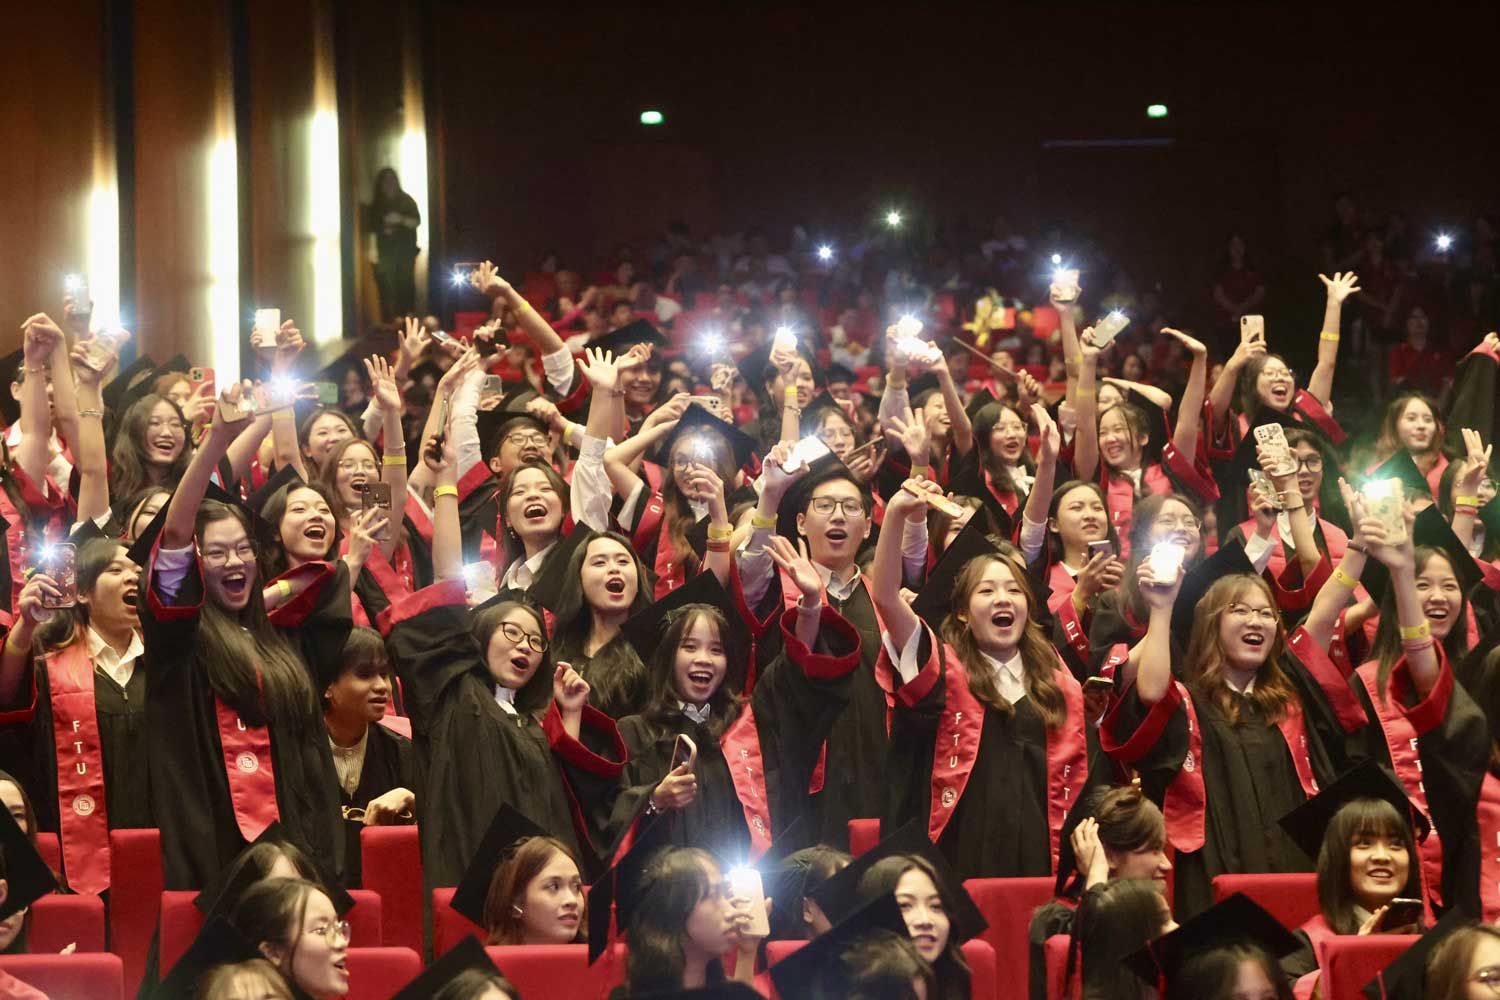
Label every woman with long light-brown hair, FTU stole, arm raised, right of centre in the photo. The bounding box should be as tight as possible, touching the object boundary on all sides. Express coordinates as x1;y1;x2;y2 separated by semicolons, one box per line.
873;480;1089;879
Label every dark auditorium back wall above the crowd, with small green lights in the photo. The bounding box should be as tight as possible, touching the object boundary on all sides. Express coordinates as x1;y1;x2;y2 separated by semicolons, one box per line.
434;0;1500;329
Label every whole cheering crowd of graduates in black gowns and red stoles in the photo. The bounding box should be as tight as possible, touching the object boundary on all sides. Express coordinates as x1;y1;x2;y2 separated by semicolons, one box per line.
0;206;1500;1000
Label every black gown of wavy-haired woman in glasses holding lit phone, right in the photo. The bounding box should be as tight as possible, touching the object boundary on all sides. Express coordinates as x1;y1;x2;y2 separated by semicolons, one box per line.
1107;677;1341;921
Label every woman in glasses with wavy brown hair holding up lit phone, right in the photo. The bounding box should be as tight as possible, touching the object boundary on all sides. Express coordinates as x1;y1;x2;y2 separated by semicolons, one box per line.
1100;559;1344;916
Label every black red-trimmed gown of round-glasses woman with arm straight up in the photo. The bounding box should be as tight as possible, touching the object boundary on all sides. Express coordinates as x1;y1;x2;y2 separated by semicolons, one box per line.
386;580;624;886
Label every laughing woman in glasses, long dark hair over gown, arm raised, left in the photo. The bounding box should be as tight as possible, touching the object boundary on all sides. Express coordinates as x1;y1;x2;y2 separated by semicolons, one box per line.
141;387;350;889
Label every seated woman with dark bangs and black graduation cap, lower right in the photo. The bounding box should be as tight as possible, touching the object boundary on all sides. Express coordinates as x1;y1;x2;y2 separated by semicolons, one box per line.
1281;757;1428;994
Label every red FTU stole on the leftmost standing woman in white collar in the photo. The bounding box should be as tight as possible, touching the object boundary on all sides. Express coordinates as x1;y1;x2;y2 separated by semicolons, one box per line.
47;634;110;895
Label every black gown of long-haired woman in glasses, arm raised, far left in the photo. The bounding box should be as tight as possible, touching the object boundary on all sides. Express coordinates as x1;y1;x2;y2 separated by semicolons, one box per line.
137;568;350;889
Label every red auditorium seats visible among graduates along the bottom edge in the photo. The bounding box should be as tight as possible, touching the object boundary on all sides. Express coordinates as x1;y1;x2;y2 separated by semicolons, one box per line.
14;820;1407;997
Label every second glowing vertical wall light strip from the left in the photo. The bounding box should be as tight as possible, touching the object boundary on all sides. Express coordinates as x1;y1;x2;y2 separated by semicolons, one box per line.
207;130;240;385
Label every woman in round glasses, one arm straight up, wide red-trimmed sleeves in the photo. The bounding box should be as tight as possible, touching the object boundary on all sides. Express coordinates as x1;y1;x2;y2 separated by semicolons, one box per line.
386;419;624;886
